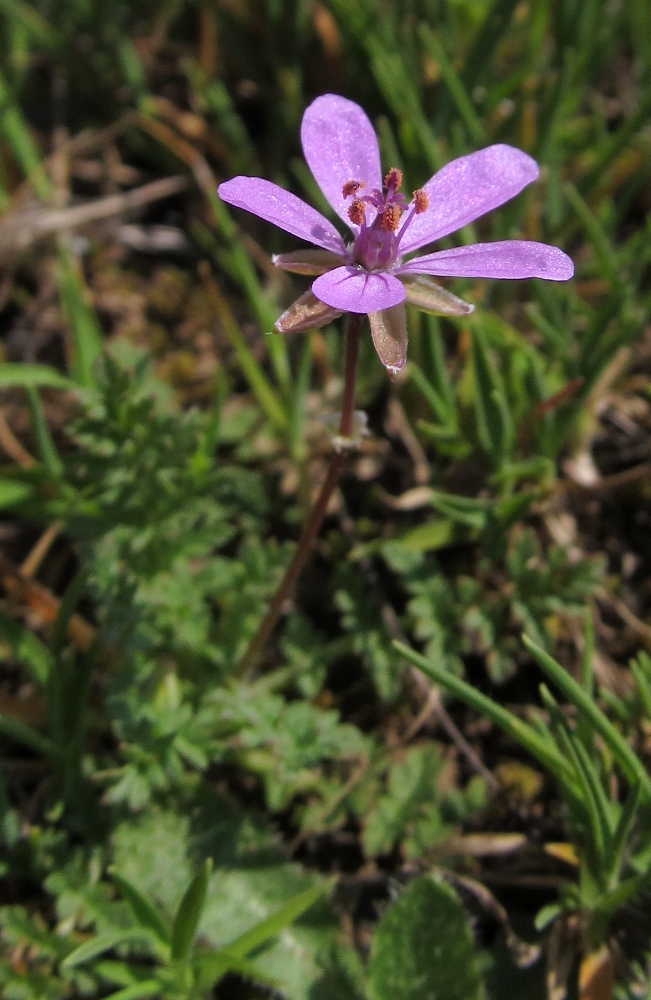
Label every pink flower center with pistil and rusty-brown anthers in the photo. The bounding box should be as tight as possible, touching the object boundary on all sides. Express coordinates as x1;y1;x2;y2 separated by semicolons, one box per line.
342;167;429;271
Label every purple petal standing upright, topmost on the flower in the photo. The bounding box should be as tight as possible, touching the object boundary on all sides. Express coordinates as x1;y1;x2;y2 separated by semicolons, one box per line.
301;94;382;232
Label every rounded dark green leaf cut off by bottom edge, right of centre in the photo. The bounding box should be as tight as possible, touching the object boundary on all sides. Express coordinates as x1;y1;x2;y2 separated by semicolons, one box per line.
368;876;482;1000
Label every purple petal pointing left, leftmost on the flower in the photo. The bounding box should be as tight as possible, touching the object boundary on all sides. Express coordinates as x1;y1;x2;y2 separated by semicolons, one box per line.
217;177;345;256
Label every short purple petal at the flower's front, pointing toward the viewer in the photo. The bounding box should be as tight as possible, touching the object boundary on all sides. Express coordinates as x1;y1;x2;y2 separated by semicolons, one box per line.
312;264;405;313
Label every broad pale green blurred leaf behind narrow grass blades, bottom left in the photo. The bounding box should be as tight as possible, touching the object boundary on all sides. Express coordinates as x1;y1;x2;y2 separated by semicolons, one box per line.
113;804;337;1000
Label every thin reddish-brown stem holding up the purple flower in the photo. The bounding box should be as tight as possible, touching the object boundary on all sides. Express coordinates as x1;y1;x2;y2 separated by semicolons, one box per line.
235;313;363;677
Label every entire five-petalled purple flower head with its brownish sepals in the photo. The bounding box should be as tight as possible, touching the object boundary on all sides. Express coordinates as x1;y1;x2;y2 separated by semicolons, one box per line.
219;94;574;374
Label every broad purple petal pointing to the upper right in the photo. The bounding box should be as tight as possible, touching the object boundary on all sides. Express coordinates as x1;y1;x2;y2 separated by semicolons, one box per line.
400;143;538;254
